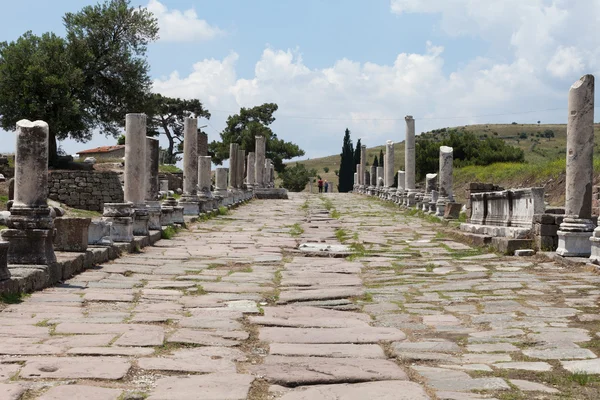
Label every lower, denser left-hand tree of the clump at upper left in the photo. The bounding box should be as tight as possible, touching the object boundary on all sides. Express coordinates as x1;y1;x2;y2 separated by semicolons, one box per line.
0;32;86;162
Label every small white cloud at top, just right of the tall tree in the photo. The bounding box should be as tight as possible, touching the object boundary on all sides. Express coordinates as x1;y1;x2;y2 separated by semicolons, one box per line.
146;0;224;42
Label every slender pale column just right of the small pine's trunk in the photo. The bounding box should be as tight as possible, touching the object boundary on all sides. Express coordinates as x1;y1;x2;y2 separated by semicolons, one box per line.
179;117;200;215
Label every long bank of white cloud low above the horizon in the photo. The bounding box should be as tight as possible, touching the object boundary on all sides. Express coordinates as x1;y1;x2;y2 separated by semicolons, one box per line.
154;42;566;157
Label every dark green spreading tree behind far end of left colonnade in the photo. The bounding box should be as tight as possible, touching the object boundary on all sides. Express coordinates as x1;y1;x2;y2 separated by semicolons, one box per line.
208;103;305;173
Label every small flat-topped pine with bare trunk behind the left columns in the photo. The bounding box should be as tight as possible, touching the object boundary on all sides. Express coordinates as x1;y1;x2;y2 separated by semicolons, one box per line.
146;94;210;164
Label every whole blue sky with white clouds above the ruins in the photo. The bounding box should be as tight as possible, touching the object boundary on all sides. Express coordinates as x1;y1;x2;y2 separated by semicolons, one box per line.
0;0;600;161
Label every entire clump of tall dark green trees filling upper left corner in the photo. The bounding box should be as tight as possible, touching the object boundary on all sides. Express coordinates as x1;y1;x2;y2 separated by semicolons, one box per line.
0;0;158;164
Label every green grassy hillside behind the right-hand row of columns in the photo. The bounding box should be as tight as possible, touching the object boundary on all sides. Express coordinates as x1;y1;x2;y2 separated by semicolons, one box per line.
288;124;600;205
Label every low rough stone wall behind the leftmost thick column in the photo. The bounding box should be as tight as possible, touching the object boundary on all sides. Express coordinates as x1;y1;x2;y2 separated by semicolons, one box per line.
48;171;124;211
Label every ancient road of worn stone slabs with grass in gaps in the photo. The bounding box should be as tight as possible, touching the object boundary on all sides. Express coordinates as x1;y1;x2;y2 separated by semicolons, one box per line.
0;194;600;400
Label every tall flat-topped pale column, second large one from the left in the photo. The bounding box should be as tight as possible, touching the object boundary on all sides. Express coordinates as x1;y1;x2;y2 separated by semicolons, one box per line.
123;114;150;236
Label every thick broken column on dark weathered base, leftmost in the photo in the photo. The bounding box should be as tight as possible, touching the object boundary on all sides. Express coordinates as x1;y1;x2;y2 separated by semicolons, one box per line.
0;120;56;266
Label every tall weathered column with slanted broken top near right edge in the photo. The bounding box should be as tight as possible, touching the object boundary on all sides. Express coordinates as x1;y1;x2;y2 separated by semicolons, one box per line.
556;75;600;256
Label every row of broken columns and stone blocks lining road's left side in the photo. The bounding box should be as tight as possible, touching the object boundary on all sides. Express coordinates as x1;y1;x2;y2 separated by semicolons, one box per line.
0;114;280;294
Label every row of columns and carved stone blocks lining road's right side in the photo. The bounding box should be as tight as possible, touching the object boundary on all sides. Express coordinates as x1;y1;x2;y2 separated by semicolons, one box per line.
354;75;600;264
